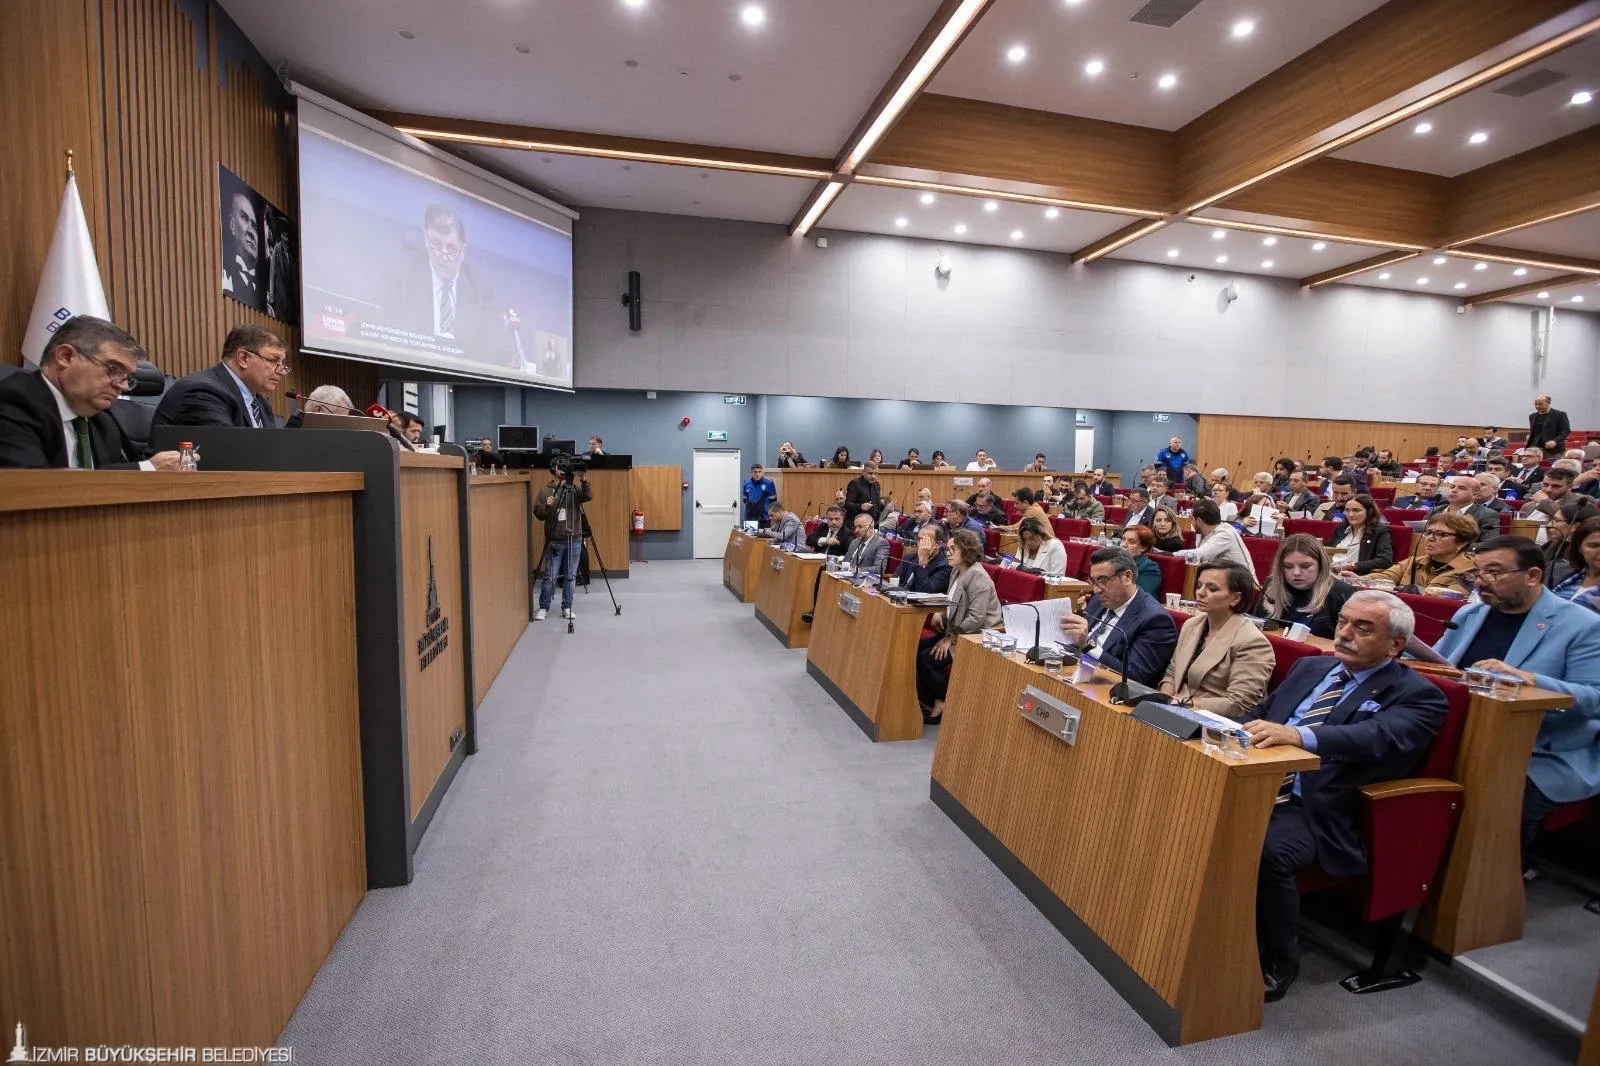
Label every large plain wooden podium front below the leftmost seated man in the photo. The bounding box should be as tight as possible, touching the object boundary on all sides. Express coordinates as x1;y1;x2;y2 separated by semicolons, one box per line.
0;472;366;1047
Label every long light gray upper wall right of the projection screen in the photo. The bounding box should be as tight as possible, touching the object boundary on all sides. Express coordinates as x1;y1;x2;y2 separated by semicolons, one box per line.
574;210;1600;422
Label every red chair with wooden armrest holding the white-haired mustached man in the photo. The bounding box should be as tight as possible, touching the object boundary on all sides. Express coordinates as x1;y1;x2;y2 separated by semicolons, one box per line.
1299;674;1472;992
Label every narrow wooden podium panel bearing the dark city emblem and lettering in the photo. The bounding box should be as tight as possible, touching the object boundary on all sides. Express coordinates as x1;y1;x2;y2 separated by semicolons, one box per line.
400;467;477;820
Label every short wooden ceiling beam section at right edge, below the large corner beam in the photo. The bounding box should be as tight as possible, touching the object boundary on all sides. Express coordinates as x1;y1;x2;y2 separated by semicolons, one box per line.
1443;126;1600;246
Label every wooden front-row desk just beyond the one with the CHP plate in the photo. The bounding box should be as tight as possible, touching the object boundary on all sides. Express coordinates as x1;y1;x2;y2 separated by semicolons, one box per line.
805;575;928;741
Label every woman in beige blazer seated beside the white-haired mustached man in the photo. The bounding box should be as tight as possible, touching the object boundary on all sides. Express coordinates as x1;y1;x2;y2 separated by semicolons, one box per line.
1162;565;1272;720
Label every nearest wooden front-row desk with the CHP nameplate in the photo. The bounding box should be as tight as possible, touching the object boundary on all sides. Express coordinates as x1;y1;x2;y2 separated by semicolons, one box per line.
933;637;1318;1044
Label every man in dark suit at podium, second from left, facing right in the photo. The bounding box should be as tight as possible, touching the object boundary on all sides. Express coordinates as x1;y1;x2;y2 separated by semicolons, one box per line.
150;325;290;429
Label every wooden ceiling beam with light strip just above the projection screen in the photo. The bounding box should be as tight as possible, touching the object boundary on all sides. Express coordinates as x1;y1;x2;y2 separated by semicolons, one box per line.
370;110;834;178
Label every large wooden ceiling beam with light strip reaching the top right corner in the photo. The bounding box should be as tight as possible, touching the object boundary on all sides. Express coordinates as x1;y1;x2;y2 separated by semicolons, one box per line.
1176;0;1600;214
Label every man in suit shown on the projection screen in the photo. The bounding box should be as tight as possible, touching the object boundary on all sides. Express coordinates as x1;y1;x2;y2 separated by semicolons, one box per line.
382;203;508;367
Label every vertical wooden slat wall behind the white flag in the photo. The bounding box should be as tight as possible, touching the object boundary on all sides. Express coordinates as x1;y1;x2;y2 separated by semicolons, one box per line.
0;0;378;406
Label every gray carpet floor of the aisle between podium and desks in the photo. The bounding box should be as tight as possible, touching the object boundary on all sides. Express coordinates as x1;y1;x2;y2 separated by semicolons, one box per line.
280;562;1571;1066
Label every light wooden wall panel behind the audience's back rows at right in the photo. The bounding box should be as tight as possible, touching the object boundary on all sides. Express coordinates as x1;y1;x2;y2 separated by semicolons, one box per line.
1190;415;1484;485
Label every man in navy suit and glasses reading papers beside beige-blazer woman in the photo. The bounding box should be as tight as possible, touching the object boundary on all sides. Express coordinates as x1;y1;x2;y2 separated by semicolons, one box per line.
1061;547;1178;688
